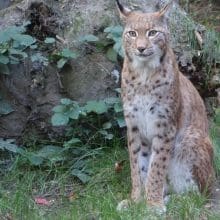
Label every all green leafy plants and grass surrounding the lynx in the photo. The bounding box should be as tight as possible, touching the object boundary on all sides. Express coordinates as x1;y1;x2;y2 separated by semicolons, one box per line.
0;1;220;220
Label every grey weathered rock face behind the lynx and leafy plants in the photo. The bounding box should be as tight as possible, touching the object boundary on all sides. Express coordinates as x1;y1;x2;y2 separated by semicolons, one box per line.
0;0;217;138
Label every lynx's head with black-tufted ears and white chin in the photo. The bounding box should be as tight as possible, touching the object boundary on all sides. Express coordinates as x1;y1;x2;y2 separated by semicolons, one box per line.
116;0;172;68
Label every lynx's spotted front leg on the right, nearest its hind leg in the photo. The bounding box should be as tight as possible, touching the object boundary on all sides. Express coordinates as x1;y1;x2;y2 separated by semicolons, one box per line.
145;135;173;211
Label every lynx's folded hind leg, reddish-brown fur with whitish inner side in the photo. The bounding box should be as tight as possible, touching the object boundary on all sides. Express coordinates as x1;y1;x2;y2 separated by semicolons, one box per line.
168;129;214;193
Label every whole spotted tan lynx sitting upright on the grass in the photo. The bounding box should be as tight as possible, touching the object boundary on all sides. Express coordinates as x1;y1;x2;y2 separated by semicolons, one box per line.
116;0;214;210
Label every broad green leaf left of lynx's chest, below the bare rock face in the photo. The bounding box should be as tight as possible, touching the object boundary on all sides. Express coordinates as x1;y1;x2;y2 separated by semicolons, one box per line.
85;101;108;114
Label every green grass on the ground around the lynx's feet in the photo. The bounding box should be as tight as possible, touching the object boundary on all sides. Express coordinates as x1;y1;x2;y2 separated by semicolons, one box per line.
0;137;220;220
